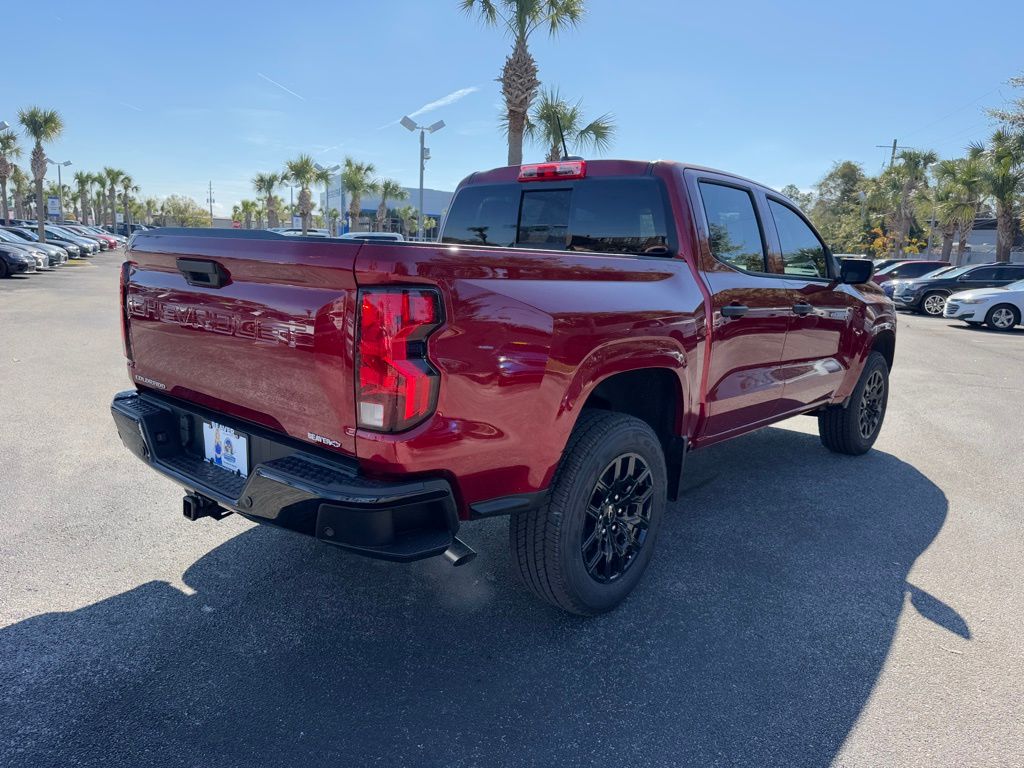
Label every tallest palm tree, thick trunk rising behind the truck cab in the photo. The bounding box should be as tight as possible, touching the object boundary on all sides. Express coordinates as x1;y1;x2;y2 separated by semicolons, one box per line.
460;0;584;165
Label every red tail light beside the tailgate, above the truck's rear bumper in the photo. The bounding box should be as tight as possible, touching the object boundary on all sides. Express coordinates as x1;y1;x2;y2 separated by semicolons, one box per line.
355;288;441;432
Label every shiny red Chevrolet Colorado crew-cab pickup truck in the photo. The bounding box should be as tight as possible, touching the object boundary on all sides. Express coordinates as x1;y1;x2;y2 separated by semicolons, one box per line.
112;159;896;614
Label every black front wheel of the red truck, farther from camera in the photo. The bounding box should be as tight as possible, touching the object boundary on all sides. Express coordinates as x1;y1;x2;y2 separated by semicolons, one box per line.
818;352;889;456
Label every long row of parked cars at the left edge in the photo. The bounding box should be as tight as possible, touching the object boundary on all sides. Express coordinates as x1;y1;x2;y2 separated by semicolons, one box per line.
0;220;127;278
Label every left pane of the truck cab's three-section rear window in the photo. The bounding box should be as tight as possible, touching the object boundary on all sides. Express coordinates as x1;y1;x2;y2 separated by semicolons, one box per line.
441;184;519;247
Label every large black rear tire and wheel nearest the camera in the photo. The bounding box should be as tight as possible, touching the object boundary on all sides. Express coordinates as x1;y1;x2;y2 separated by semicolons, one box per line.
509;411;668;615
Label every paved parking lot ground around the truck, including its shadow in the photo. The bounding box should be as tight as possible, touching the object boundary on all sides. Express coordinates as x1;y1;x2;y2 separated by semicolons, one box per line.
0;259;1024;766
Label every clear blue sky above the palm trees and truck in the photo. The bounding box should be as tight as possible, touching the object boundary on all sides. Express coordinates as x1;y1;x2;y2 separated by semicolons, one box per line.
0;0;1024;213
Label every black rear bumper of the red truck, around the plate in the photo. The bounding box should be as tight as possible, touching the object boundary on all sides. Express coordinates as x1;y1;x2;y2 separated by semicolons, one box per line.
111;391;459;561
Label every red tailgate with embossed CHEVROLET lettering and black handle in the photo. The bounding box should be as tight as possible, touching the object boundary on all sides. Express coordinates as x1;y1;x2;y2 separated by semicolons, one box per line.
122;229;360;454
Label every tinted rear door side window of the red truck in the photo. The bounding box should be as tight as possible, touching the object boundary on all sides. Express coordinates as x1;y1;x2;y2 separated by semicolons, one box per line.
699;181;767;272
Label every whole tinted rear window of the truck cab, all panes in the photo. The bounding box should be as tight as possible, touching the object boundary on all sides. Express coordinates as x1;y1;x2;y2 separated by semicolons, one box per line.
441;177;672;256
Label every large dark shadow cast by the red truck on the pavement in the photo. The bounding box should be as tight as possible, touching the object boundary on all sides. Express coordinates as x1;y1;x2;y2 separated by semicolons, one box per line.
0;428;958;766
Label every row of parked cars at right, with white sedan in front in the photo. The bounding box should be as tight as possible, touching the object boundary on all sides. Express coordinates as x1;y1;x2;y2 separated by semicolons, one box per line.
872;259;1024;331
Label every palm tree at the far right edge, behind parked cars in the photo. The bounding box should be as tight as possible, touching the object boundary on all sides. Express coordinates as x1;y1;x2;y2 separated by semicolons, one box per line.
969;130;1024;261
